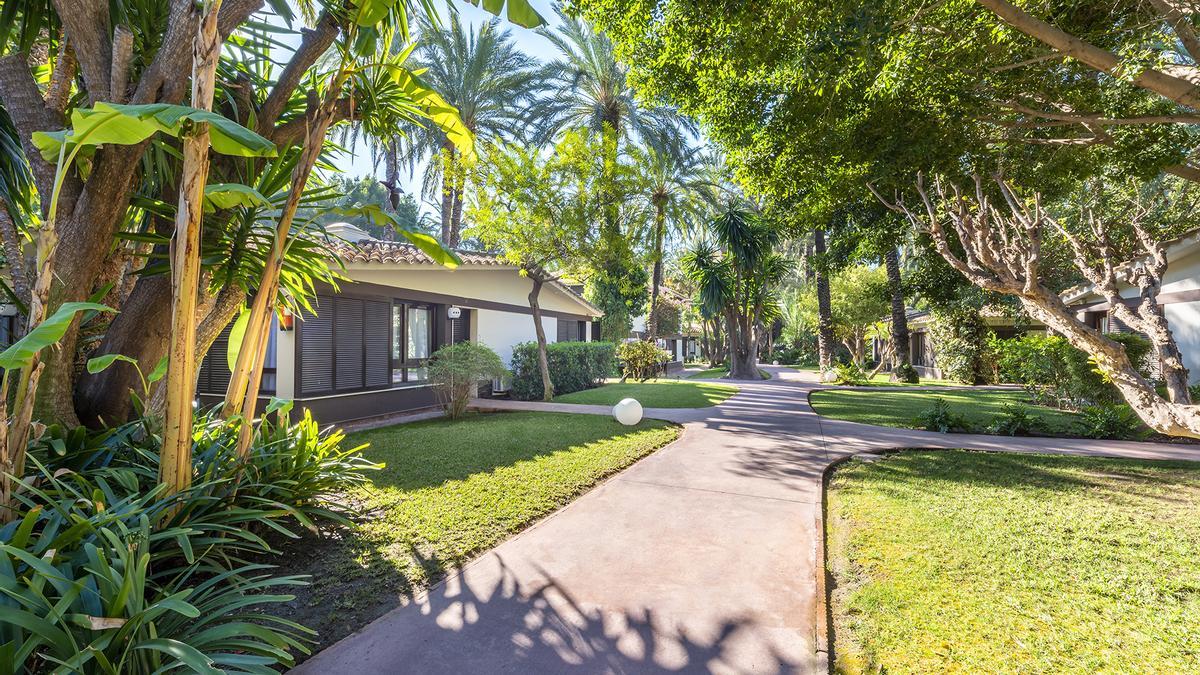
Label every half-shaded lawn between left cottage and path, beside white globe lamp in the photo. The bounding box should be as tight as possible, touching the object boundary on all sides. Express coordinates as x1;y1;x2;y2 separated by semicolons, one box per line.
274;412;679;646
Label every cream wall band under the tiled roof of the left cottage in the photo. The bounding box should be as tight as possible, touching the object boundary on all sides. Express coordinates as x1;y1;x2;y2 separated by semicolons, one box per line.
346;263;595;321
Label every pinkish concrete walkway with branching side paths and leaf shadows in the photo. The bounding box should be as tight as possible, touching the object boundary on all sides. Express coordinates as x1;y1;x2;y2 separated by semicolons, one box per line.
293;366;1200;675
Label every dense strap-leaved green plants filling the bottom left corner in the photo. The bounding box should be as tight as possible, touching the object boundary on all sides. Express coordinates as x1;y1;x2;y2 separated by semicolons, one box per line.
0;401;377;674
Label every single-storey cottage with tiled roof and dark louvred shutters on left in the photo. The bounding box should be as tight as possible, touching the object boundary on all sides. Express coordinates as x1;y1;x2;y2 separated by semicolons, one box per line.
199;223;601;423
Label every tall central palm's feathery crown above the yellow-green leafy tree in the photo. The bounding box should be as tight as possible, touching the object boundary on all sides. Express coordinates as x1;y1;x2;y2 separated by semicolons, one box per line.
527;8;696;237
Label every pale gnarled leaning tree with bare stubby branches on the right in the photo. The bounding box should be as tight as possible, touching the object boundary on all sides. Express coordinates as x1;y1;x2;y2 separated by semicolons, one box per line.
872;175;1200;437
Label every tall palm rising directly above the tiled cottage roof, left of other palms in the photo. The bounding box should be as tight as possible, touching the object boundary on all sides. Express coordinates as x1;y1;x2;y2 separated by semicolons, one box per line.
389;14;541;247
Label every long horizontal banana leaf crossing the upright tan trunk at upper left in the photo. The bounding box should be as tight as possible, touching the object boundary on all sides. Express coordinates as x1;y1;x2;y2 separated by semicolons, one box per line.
32;103;276;162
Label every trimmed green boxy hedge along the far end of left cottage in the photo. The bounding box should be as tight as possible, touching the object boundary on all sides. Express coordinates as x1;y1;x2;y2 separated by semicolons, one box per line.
509;342;616;401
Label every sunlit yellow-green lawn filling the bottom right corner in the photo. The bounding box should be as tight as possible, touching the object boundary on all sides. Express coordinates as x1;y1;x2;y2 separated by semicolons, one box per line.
827;450;1200;674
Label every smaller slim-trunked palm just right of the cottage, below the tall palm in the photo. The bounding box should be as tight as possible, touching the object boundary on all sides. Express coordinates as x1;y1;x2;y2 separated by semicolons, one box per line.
637;148;708;340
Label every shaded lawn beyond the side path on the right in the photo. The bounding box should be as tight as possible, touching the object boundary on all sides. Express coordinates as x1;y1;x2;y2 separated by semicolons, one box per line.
809;387;1076;435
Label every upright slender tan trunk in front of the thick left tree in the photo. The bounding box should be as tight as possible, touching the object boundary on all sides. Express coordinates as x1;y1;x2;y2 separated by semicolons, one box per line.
158;0;221;492
